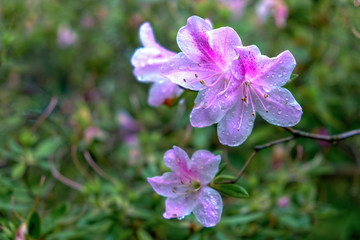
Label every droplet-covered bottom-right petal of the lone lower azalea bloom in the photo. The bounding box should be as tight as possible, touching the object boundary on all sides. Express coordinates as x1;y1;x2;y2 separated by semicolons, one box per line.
193;186;223;227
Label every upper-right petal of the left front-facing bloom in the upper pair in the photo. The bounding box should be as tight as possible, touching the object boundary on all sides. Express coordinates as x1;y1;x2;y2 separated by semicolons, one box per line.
208;27;242;68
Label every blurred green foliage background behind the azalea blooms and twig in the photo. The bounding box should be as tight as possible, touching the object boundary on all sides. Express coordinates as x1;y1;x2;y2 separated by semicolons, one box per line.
0;0;360;240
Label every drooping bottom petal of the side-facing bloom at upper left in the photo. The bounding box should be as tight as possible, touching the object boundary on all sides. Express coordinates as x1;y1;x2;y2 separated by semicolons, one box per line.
148;78;183;107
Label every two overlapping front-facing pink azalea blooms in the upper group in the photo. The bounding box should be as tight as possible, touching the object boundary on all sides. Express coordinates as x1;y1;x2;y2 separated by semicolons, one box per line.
163;16;302;146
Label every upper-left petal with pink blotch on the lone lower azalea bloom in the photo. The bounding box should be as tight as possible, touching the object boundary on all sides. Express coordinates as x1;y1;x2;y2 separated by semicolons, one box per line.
164;146;193;181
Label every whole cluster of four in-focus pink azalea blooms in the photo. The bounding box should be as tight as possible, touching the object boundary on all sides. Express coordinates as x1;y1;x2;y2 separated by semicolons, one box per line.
131;16;302;227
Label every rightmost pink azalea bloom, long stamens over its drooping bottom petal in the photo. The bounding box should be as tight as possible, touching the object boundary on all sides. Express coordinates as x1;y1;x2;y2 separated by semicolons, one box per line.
218;46;302;146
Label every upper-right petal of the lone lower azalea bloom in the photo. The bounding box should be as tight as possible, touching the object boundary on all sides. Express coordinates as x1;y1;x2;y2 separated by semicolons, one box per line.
190;150;221;185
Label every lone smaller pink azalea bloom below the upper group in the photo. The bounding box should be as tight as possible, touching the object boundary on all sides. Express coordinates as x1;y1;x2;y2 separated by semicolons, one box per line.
148;146;223;227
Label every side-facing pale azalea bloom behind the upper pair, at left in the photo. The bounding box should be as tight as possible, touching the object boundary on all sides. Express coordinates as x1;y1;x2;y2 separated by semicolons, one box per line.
131;22;182;107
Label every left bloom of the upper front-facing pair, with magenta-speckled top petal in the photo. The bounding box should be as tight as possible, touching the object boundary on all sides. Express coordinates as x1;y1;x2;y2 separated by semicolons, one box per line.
163;16;241;127
